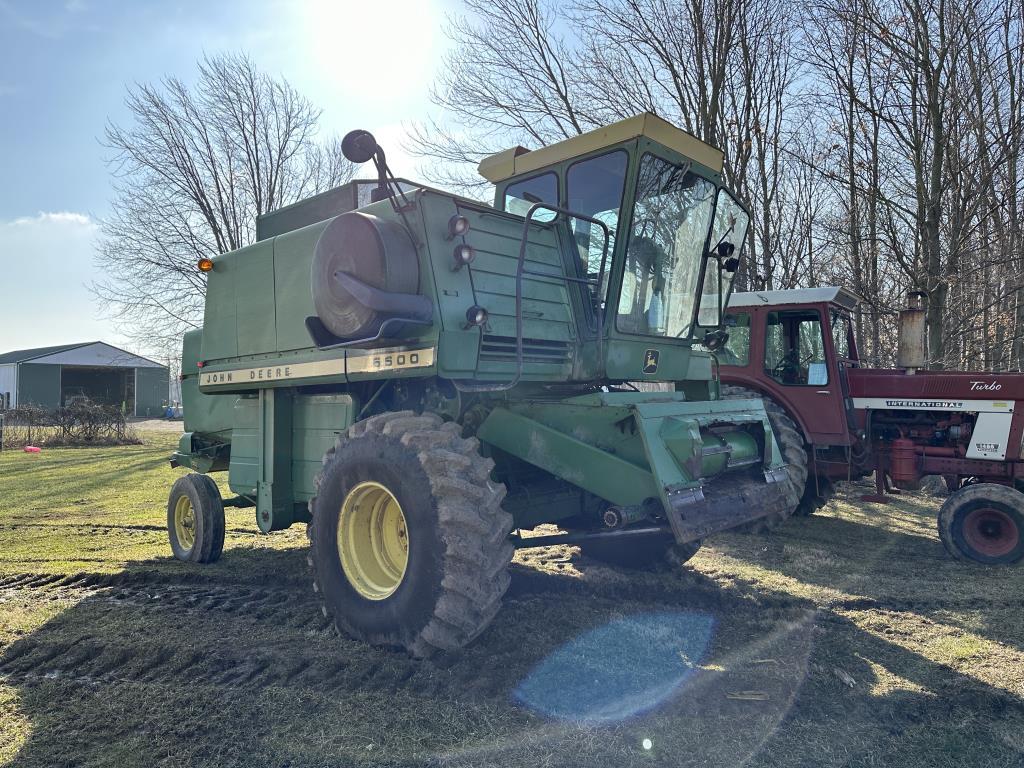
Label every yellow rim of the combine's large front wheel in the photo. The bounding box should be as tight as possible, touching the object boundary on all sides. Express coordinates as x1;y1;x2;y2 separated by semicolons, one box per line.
338;481;409;600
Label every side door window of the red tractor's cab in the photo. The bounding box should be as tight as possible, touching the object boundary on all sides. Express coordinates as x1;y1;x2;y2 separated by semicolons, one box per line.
765;310;828;387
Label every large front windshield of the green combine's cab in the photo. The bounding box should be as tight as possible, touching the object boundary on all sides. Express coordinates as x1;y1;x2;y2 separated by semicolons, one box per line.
618;154;716;337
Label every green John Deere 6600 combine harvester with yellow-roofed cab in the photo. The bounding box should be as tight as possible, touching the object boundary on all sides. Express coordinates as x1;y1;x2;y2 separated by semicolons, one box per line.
167;115;805;656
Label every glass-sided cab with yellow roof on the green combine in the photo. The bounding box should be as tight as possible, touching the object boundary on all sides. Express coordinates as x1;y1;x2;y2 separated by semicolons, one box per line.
479;114;750;380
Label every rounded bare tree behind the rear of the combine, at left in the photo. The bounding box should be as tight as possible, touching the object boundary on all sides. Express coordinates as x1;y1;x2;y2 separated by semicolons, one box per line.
92;54;352;353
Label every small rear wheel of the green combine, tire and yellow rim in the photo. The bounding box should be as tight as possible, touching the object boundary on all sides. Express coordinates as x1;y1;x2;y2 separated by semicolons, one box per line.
167;472;224;563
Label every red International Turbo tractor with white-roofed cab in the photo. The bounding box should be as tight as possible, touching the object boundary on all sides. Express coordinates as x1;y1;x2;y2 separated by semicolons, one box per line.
717;288;1024;564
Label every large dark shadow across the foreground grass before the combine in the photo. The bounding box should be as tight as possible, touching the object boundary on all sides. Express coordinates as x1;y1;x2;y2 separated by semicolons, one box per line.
0;547;1024;768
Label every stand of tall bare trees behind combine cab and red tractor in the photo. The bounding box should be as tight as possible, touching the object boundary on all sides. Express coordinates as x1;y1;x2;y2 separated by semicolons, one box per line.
414;0;1024;370
